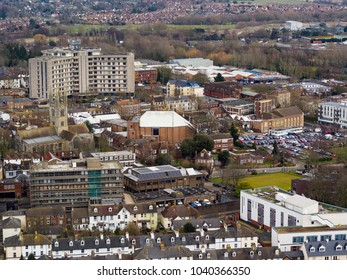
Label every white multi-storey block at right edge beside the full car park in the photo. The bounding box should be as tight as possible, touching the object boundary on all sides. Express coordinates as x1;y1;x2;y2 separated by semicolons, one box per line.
318;100;347;128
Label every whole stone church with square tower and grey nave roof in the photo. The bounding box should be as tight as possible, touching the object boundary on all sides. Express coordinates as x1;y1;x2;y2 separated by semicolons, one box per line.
15;93;94;153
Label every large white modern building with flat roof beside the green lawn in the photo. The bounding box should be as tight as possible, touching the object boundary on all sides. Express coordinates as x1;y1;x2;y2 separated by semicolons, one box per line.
240;187;347;229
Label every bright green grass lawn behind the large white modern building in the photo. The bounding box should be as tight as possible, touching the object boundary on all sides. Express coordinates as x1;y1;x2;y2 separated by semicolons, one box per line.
210;172;303;190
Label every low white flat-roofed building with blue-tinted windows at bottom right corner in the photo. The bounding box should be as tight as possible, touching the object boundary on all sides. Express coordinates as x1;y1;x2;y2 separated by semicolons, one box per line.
271;227;347;252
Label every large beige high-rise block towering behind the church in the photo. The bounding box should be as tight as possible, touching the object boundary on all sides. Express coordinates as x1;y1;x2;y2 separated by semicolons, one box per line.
29;40;135;99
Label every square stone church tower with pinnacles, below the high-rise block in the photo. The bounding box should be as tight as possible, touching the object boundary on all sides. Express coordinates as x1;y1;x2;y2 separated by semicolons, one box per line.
49;92;68;135
